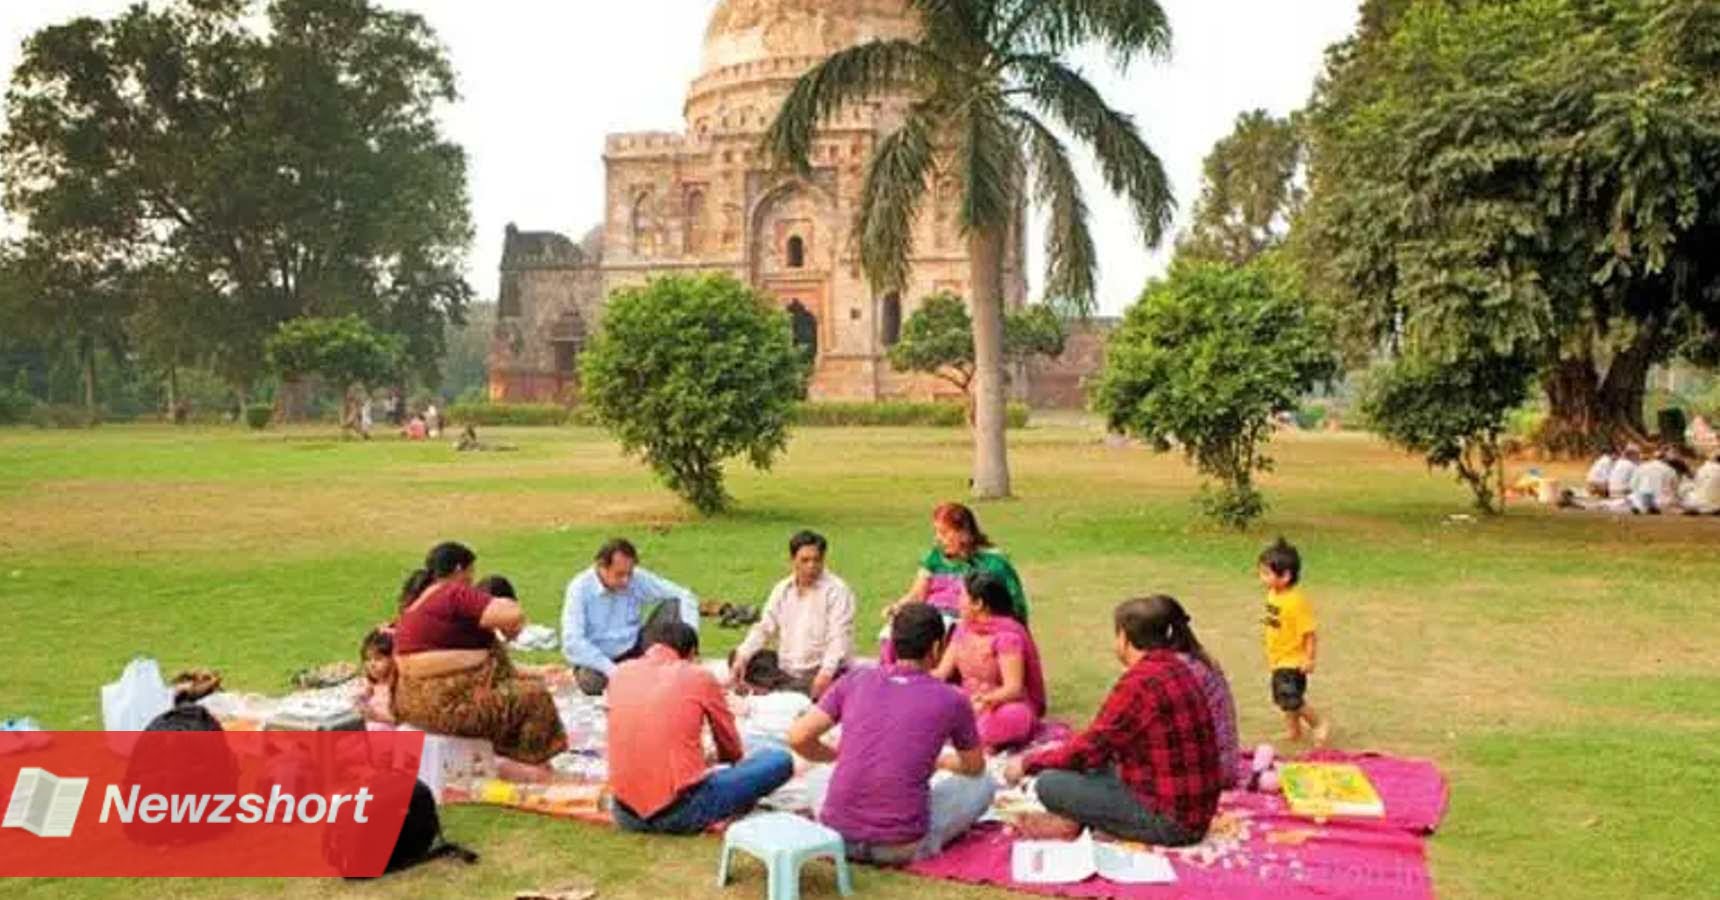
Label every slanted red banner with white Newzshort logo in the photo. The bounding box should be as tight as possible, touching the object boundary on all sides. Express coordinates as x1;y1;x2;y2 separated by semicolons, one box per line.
0;731;423;878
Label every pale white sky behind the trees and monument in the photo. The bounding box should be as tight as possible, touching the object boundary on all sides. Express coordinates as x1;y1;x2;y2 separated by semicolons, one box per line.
0;0;1357;313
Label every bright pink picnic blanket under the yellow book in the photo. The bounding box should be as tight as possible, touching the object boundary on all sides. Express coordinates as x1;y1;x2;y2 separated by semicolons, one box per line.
908;750;1448;900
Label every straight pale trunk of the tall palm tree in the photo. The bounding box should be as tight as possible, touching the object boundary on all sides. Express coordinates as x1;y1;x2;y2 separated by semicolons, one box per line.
968;225;1010;499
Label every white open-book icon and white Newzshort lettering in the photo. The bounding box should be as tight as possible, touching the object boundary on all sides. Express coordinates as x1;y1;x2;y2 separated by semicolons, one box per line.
5;769;375;838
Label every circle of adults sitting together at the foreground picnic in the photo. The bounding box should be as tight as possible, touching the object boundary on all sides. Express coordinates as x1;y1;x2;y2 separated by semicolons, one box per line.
366;504;1237;864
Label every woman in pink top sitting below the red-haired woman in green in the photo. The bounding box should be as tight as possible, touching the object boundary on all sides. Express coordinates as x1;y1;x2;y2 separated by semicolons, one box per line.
934;571;1046;750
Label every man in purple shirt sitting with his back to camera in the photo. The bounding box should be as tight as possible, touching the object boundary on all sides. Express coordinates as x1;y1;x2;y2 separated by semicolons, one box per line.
788;604;996;866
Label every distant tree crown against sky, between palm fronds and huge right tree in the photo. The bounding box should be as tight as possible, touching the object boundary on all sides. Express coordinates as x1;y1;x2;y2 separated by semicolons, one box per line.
1176;110;1304;265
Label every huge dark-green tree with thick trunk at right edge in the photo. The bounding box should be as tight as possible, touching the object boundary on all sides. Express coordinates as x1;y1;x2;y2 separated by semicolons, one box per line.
1295;0;1720;451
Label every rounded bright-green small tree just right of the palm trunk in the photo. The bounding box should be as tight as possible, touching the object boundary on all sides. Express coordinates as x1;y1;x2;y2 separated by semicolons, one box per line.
1096;258;1338;528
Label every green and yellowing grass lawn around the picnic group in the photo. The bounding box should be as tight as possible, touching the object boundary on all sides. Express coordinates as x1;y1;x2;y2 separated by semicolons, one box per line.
0;423;1720;900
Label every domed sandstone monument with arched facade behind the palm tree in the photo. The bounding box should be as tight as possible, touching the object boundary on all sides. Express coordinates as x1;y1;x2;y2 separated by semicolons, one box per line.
490;0;1066;401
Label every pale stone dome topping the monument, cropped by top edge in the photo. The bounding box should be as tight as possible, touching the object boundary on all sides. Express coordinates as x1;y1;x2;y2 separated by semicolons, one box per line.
702;0;918;74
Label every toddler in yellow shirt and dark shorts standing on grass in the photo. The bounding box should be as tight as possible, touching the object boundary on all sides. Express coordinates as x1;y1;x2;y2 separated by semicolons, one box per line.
1259;537;1331;747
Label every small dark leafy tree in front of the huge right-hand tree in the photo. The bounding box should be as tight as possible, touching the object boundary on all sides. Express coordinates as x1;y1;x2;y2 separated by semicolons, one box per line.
1361;353;1534;515
